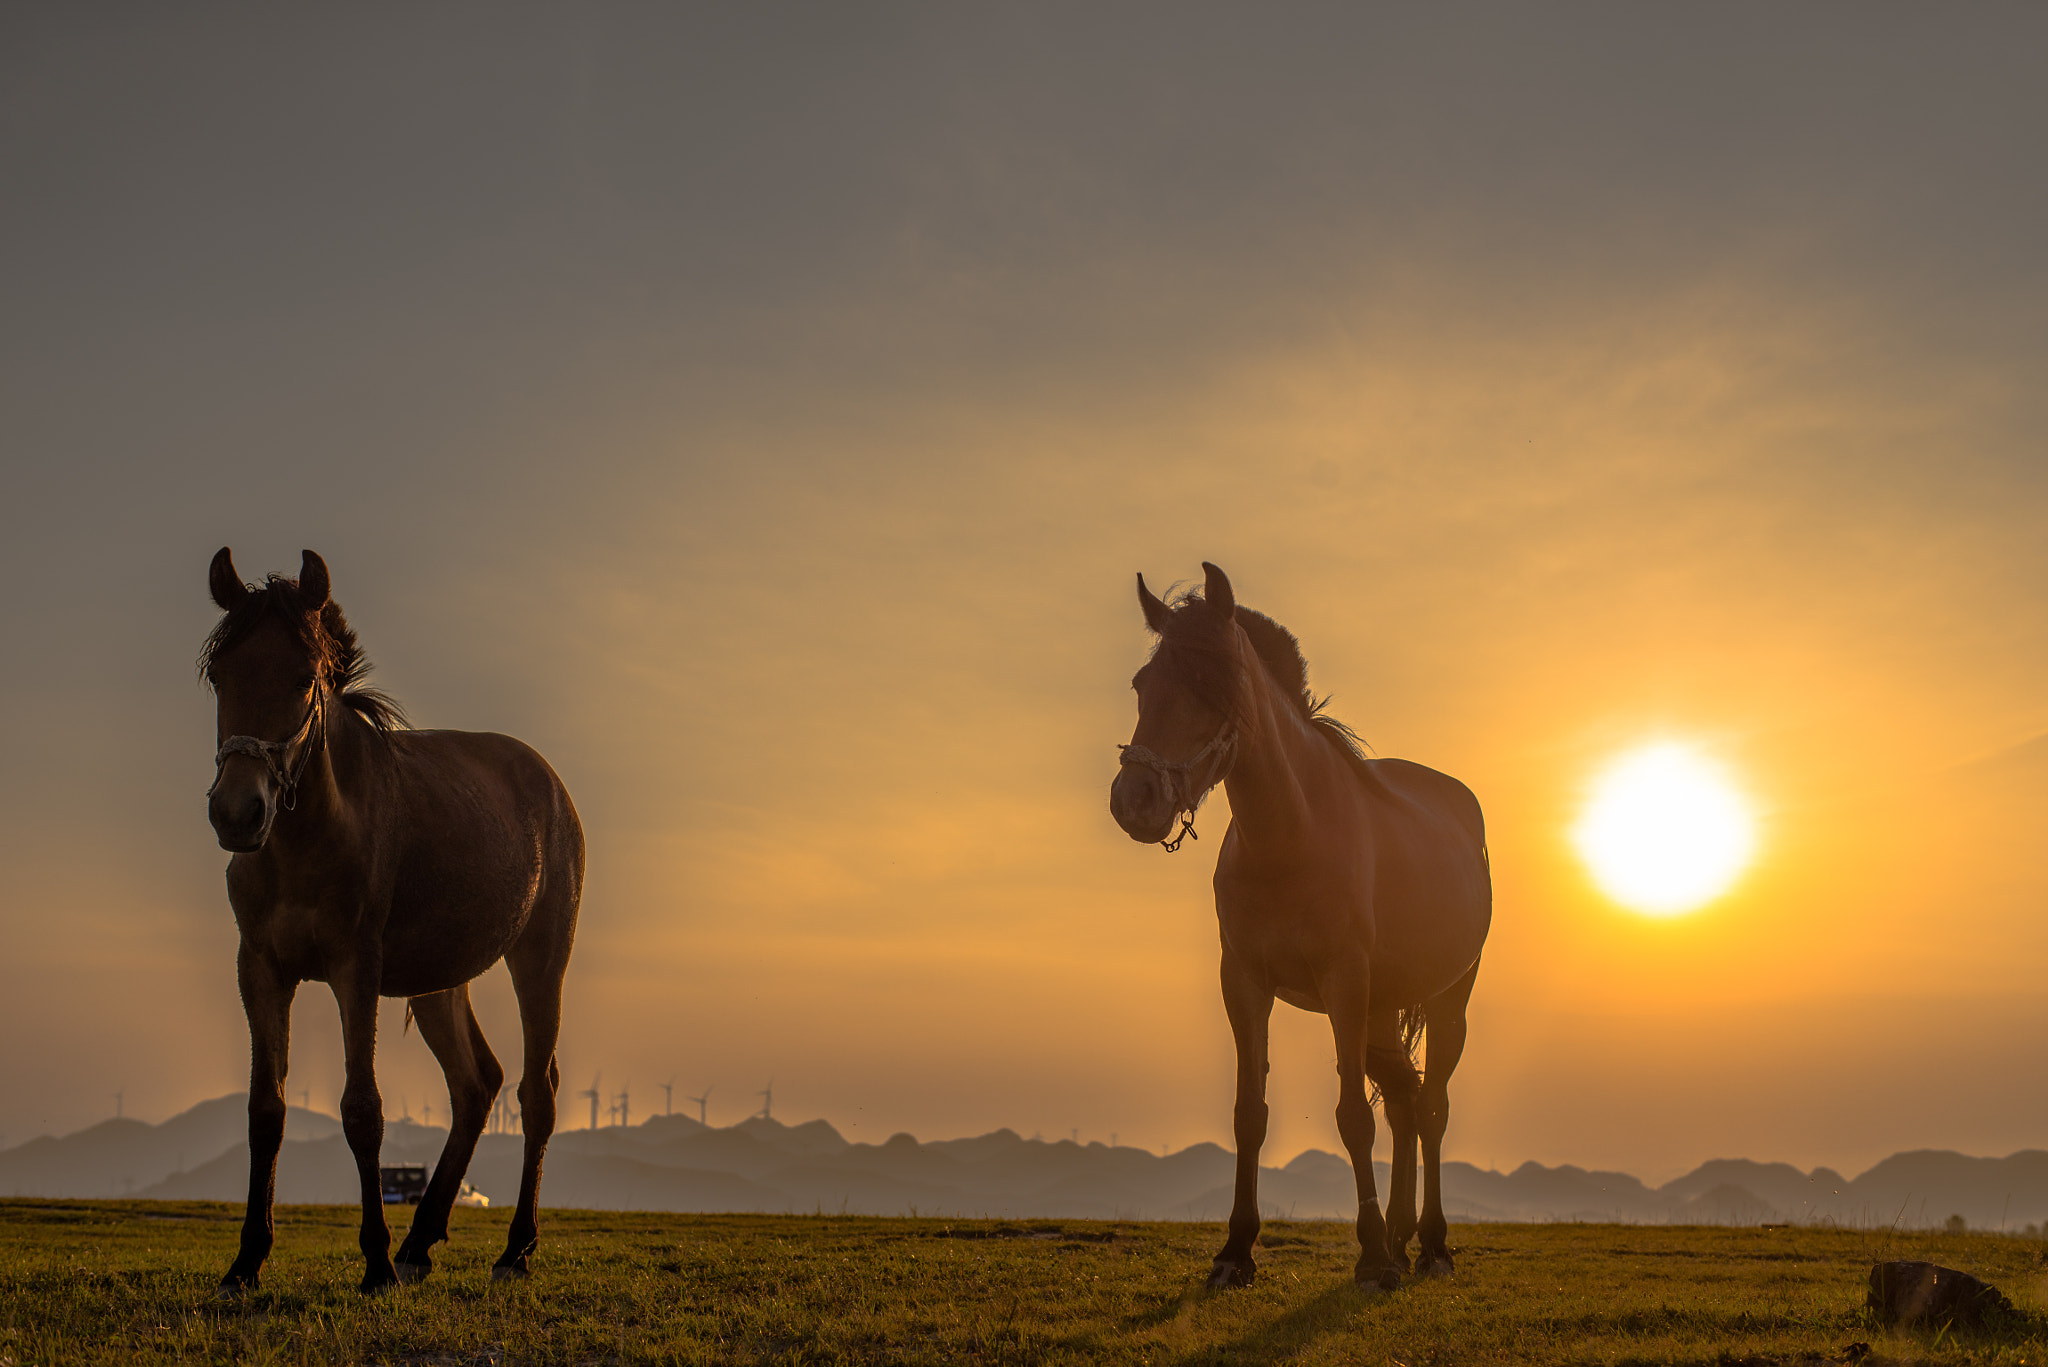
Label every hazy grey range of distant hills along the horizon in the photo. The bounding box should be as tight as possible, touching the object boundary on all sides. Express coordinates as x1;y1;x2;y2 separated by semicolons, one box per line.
0;1096;2048;1232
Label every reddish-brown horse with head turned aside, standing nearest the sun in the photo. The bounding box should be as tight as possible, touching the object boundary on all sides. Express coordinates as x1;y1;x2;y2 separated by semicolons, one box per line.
1110;562;1493;1293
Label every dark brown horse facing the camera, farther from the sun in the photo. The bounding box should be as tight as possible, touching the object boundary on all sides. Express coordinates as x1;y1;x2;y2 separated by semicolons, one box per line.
199;545;584;1295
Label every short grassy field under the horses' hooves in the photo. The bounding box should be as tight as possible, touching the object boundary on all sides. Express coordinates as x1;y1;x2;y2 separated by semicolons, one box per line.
0;1201;2048;1367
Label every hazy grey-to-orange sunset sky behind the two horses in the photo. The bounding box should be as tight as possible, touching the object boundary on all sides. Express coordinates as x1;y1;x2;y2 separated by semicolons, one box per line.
0;4;2048;1178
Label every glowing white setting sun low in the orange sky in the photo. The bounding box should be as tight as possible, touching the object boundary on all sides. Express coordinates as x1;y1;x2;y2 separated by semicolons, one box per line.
1573;742;1755;916
